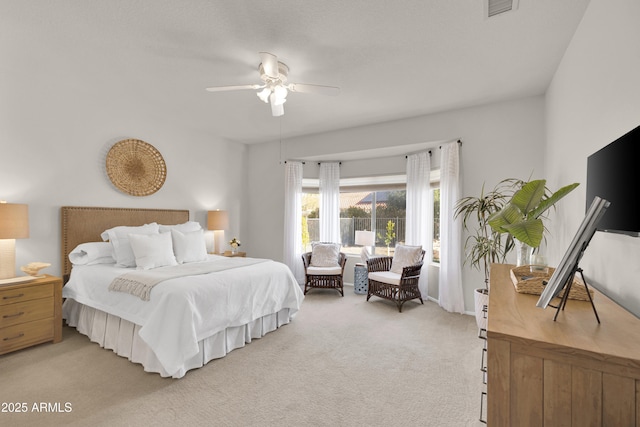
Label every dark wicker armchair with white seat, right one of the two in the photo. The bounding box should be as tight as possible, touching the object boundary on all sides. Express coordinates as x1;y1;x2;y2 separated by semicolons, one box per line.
367;250;425;313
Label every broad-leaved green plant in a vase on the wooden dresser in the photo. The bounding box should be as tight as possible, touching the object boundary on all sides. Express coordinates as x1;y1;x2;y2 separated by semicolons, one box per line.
488;179;579;266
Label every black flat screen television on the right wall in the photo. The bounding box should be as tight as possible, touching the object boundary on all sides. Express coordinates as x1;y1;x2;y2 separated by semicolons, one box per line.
586;126;640;237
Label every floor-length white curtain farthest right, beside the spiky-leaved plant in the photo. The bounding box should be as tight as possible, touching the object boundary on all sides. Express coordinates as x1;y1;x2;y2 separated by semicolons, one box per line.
439;142;464;313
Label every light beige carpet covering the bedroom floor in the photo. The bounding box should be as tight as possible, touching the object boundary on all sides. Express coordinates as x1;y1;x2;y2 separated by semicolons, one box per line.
0;287;483;427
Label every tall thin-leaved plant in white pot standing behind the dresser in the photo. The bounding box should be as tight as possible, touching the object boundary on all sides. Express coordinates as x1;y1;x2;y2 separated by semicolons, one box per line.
454;179;520;329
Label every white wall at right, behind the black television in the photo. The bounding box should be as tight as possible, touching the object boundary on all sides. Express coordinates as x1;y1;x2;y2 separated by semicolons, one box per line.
545;0;640;316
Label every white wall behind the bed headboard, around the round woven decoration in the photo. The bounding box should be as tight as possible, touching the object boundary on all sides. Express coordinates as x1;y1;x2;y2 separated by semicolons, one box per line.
0;79;246;275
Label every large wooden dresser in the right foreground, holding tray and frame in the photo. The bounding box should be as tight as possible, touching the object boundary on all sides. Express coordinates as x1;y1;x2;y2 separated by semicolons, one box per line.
487;264;640;427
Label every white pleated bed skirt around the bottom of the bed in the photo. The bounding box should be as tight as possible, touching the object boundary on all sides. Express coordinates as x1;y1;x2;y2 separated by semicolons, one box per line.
62;298;291;378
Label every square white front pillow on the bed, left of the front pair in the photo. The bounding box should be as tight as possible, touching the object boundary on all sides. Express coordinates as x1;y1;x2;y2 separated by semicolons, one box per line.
129;233;178;270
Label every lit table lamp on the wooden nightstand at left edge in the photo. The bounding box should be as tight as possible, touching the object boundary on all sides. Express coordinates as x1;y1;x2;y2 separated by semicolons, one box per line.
0;201;32;283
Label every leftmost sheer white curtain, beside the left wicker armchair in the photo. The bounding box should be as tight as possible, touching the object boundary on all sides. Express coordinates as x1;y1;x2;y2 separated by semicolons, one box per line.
284;162;304;283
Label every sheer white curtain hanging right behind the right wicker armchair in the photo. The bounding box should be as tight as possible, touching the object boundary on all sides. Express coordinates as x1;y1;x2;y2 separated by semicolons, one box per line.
405;152;433;298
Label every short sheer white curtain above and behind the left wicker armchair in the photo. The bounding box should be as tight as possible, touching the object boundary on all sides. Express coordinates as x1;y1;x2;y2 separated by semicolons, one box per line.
320;163;342;243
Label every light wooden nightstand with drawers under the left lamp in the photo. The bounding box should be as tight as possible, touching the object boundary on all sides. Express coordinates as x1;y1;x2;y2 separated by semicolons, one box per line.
0;275;62;354
